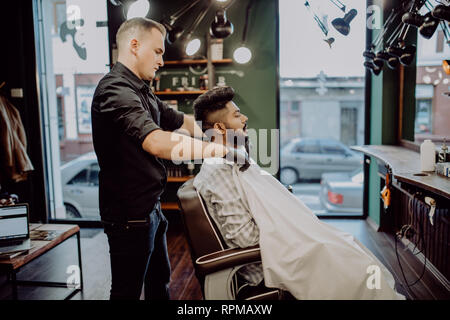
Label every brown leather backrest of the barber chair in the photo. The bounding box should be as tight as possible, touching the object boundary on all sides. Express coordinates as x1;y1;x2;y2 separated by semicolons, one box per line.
177;179;227;261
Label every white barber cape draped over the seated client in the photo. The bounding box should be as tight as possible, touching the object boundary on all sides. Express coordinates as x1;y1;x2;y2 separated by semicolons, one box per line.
229;160;405;300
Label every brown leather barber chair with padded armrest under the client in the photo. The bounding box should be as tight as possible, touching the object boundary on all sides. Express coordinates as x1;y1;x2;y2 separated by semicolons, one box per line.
177;179;292;300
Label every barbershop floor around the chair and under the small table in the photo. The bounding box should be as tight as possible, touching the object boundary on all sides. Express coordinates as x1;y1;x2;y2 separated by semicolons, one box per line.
0;215;450;300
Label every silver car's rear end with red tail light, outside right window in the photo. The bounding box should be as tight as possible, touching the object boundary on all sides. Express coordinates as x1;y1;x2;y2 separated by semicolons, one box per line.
320;168;364;213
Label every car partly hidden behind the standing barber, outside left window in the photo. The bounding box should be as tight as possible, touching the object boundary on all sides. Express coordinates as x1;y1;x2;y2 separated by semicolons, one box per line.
61;152;100;220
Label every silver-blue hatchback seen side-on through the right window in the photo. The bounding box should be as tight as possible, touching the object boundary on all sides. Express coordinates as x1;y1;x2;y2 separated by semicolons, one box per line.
280;138;363;184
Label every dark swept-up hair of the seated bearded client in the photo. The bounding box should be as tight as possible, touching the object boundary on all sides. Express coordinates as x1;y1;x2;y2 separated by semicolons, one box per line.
194;87;234;131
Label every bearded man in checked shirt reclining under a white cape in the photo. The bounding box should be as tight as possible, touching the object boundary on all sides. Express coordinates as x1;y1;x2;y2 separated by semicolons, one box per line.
194;87;404;299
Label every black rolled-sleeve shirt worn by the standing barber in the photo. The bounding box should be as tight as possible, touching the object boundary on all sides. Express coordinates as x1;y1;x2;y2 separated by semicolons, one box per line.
91;62;183;222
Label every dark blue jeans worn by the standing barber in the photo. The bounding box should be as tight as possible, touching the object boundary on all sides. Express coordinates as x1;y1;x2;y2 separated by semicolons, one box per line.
105;204;170;300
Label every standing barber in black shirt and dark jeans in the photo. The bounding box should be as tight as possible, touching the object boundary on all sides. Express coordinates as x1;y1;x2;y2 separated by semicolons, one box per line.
91;18;244;300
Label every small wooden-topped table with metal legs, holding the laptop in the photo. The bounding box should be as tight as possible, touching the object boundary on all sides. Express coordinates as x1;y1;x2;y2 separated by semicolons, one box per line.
0;224;83;300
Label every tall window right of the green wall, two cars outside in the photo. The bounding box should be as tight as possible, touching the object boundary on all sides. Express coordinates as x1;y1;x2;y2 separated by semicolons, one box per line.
279;0;366;216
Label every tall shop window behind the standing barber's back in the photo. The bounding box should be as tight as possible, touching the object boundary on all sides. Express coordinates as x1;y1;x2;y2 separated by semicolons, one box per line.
35;0;109;220
